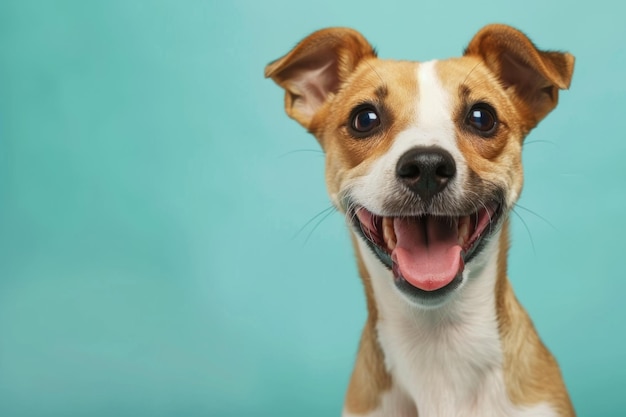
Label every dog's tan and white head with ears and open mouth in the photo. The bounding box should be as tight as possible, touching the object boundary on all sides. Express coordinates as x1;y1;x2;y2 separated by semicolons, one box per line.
266;25;573;305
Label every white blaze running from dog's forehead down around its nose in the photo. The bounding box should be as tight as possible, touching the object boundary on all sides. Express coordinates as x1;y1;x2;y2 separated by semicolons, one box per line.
350;61;468;214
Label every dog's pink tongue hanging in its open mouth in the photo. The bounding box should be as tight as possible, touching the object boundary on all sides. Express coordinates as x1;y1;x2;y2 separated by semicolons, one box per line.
391;216;464;291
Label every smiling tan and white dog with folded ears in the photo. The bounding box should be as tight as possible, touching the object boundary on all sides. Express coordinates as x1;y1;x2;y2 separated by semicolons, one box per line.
265;24;575;417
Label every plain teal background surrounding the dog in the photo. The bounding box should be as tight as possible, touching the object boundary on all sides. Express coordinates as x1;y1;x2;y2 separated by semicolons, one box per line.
0;0;626;417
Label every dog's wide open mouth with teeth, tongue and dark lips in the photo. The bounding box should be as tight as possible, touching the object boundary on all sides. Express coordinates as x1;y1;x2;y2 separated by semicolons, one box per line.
353;202;501;297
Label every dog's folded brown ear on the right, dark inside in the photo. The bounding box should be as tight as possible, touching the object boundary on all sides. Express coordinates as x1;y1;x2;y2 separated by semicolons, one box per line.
465;24;574;123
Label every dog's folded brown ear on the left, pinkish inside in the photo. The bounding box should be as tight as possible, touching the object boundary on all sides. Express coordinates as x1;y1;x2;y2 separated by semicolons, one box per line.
265;28;376;128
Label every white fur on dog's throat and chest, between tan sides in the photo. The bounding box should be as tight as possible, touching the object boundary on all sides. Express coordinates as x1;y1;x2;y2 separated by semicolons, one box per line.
344;235;556;417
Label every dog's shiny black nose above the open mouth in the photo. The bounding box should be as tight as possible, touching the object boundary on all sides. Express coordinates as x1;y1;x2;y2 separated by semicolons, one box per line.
396;147;456;201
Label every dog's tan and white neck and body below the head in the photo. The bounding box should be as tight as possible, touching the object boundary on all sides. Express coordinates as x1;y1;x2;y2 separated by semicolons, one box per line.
344;222;574;417
